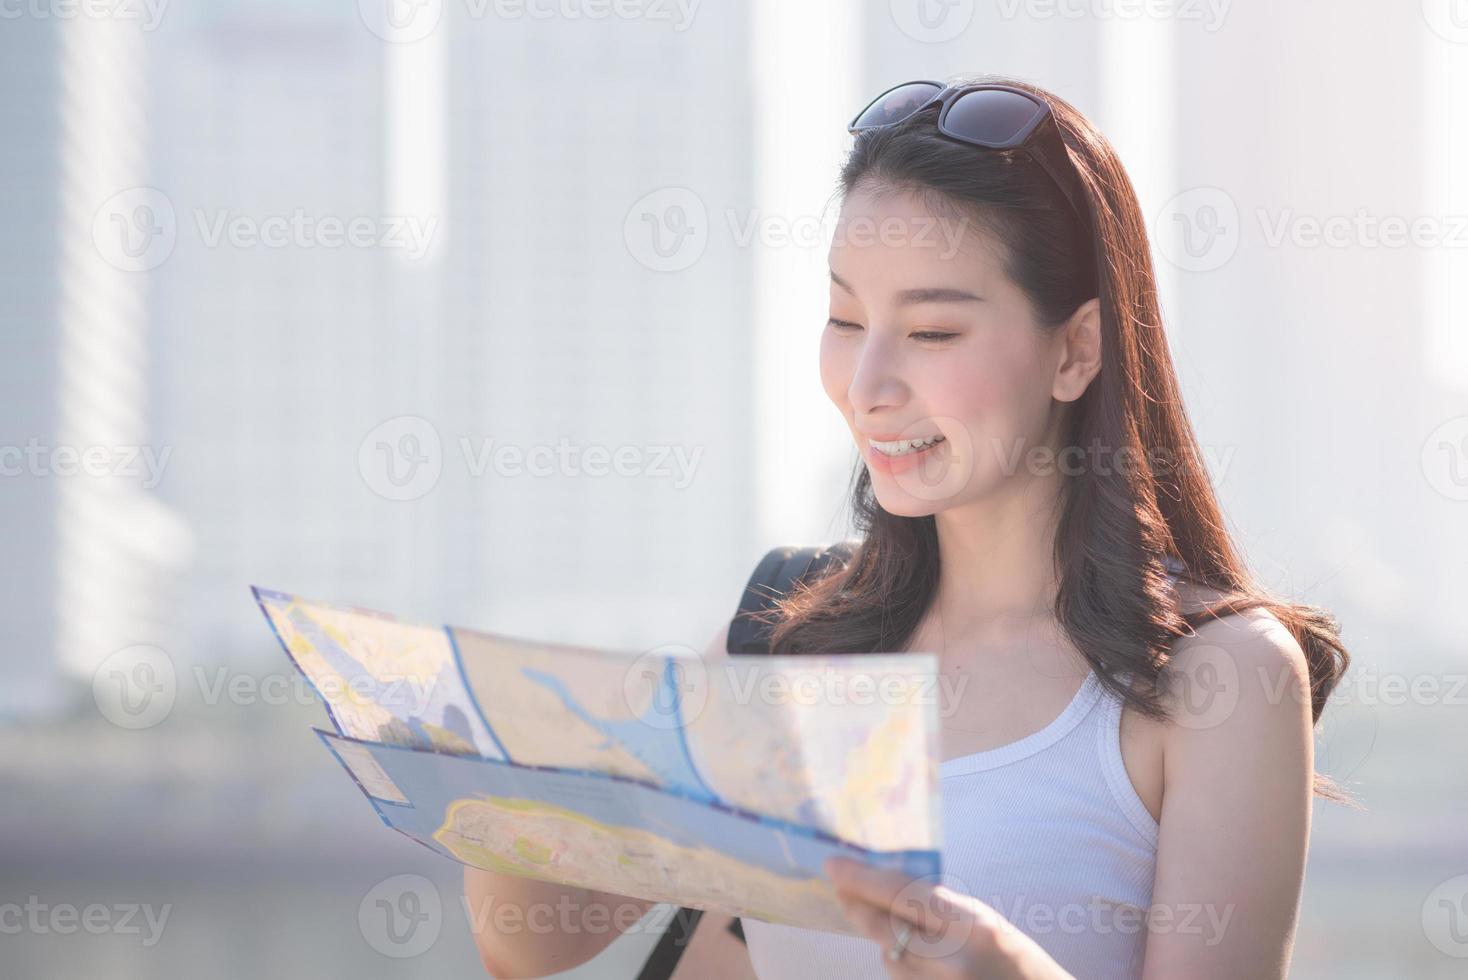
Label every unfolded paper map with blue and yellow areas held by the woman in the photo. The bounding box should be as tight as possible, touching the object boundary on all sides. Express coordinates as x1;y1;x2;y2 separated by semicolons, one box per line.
254;588;941;933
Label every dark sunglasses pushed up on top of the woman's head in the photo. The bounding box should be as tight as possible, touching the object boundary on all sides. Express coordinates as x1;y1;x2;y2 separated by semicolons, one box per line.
847;81;1089;223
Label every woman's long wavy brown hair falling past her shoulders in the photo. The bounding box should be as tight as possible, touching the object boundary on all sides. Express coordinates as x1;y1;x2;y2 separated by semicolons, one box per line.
769;76;1356;805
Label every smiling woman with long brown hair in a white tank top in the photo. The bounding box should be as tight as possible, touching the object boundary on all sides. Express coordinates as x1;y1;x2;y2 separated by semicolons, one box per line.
471;78;1349;980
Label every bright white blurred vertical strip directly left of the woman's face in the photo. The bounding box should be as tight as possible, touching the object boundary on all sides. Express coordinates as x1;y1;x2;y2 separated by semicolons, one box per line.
750;0;863;544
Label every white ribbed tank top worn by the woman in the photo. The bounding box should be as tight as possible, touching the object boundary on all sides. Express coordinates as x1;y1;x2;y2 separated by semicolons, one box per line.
740;560;1180;980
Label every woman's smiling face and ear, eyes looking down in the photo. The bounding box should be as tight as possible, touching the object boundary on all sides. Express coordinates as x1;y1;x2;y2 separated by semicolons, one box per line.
821;182;1100;516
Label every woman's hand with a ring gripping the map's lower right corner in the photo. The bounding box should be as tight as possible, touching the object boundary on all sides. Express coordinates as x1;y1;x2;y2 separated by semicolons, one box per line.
825;858;1075;980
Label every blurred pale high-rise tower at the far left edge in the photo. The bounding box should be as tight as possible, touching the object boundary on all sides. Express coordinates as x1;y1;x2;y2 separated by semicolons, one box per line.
0;9;189;716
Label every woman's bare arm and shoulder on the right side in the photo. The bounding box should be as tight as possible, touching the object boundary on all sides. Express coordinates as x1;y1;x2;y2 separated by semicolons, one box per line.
1142;610;1314;980
